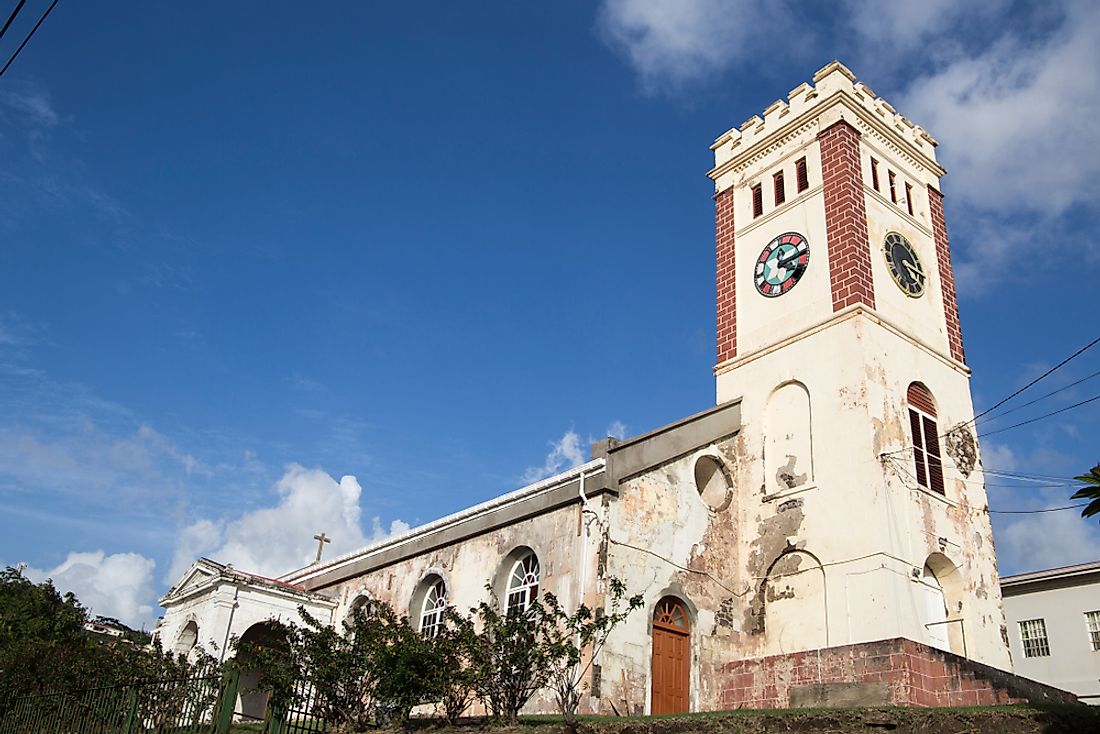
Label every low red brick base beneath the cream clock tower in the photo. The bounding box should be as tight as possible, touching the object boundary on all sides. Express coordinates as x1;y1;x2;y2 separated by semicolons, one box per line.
721;637;1077;710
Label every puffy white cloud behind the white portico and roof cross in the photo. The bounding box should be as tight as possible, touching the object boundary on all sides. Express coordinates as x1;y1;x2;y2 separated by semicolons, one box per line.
172;464;409;582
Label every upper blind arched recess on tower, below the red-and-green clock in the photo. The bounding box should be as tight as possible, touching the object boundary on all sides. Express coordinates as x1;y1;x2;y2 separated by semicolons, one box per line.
763;382;814;494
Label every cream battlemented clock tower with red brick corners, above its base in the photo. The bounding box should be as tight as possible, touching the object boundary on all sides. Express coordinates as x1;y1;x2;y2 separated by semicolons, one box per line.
708;62;1011;669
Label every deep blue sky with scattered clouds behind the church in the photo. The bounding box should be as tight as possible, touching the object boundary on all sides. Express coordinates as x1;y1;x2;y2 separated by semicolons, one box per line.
0;0;1100;624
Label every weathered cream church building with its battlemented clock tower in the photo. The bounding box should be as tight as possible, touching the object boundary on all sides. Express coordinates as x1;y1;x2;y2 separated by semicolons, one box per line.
157;62;1073;714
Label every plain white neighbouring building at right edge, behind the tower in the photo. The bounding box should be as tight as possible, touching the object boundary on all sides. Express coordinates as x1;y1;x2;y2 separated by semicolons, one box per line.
1001;561;1100;705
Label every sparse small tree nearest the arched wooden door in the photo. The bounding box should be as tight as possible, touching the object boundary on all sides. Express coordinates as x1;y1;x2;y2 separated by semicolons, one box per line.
545;577;642;732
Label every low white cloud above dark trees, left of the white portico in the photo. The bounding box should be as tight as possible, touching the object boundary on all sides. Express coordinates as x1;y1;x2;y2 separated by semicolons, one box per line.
26;550;156;628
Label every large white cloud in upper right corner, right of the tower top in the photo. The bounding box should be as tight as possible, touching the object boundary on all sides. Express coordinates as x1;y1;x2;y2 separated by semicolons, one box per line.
898;3;1100;215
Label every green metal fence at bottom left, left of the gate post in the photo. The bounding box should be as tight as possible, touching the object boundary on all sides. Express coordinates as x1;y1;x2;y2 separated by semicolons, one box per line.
0;671;239;734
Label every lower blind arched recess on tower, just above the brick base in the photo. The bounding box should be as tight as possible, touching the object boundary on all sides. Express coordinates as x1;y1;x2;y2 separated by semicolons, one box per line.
760;550;828;653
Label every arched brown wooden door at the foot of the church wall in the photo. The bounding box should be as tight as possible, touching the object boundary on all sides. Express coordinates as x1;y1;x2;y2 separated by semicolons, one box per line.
650;596;691;714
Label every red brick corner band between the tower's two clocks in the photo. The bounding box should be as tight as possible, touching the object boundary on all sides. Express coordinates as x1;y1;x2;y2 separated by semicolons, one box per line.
817;120;875;311
